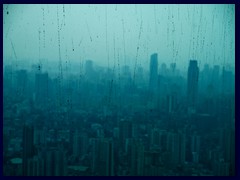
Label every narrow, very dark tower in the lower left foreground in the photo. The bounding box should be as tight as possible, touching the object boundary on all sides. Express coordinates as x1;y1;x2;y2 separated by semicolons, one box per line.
22;125;34;176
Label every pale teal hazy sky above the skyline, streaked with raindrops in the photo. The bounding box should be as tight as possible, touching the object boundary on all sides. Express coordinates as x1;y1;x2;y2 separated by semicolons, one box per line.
3;4;235;69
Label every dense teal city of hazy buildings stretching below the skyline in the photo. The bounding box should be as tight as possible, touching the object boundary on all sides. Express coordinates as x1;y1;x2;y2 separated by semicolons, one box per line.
3;53;235;176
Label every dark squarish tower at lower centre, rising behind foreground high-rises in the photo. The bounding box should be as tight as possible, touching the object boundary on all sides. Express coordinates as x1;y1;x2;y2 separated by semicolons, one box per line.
119;120;132;147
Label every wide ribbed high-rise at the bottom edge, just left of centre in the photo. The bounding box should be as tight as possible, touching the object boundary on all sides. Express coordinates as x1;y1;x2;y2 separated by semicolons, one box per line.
91;138;114;176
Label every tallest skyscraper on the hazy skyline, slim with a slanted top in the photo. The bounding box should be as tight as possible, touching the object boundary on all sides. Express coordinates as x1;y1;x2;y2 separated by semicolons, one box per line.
149;53;158;90
